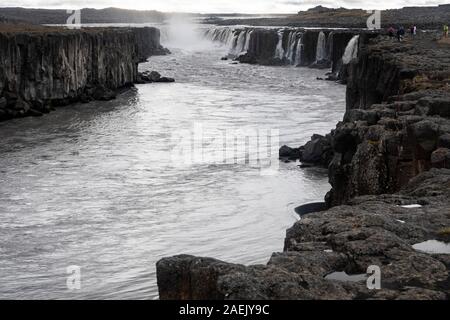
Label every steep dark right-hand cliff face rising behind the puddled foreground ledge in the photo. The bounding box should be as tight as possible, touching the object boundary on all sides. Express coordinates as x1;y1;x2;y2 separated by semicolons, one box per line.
312;33;450;206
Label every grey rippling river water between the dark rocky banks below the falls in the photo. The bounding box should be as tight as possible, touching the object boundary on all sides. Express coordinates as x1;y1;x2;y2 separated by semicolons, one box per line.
0;31;345;299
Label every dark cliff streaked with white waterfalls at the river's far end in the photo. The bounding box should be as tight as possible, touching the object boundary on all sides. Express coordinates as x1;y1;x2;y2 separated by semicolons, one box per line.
205;27;377;73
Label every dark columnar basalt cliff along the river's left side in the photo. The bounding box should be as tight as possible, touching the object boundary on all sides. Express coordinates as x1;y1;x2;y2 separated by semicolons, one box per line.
0;25;164;120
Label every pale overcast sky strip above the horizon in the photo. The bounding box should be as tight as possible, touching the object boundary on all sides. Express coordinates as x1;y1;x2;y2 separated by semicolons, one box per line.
0;0;450;13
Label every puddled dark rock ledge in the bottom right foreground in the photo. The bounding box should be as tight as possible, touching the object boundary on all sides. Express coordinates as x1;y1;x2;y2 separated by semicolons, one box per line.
157;169;450;300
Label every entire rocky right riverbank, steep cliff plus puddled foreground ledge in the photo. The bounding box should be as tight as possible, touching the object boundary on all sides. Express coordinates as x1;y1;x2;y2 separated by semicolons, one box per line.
157;33;450;299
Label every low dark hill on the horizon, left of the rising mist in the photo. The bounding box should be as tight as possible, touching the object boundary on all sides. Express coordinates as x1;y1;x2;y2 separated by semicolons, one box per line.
0;8;166;24
